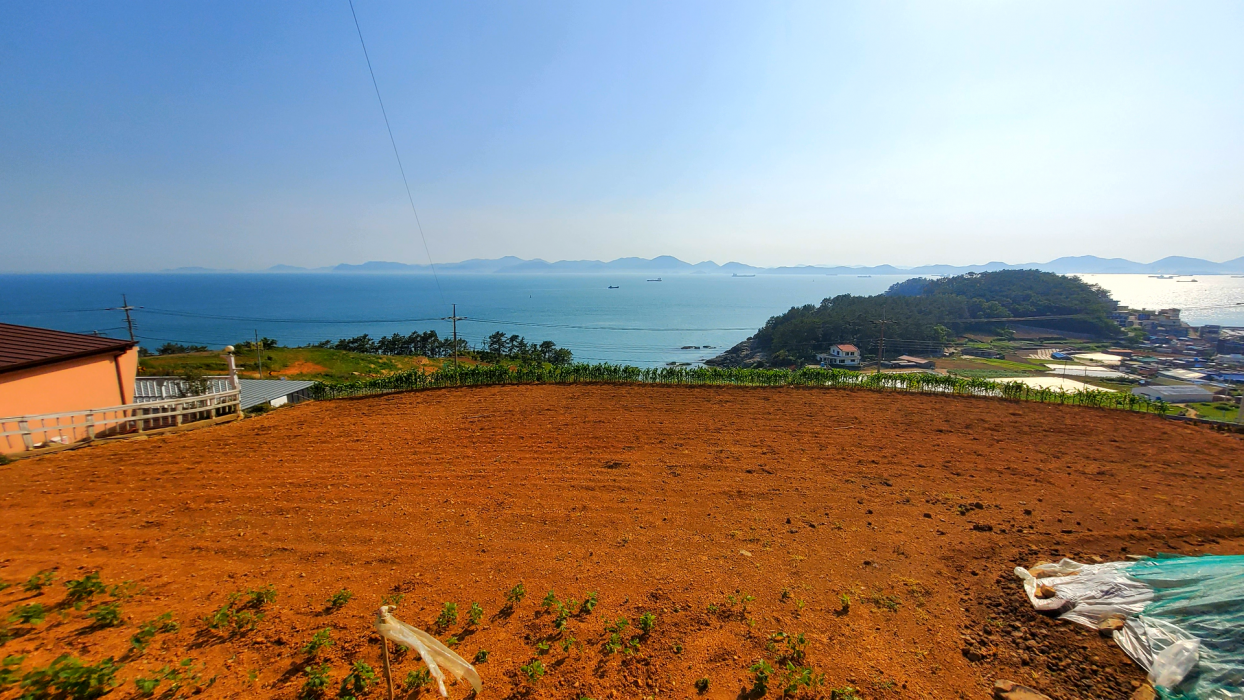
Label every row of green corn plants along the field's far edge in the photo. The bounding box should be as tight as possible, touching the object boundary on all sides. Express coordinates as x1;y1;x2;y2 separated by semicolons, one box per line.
312;364;1168;414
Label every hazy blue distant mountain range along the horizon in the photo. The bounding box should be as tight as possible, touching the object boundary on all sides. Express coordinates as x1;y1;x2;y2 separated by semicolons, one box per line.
164;255;1244;276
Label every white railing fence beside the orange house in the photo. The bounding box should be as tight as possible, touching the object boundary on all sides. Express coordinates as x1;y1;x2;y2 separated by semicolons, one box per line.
0;389;240;454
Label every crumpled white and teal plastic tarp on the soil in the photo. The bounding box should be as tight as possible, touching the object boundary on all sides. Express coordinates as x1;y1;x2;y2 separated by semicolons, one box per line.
1015;556;1244;700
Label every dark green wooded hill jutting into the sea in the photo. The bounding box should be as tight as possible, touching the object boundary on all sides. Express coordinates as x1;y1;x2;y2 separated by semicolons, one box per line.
710;270;1121;366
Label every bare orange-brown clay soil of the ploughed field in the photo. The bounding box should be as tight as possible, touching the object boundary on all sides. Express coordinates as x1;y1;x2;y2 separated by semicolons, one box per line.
0;385;1244;700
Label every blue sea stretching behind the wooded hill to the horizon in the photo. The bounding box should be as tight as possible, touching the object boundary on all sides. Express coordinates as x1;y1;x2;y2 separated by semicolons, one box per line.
0;272;1244;367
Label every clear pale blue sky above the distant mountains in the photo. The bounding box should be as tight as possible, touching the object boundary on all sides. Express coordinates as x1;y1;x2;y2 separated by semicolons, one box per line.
0;0;1244;272
